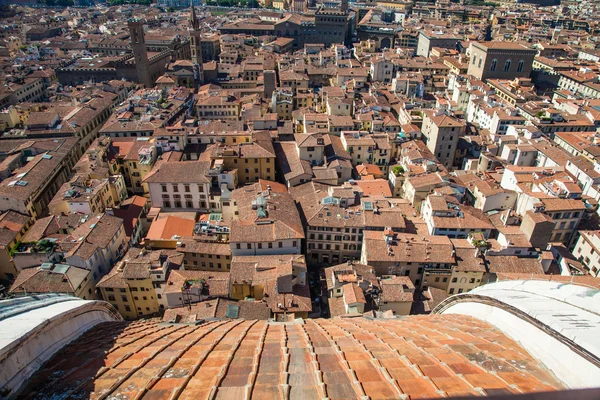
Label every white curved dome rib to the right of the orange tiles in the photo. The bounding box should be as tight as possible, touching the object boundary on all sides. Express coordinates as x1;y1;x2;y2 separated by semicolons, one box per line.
433;280;600;388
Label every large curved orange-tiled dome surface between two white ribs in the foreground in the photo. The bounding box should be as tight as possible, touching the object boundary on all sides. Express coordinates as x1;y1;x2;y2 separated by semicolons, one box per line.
22;316;563;399
